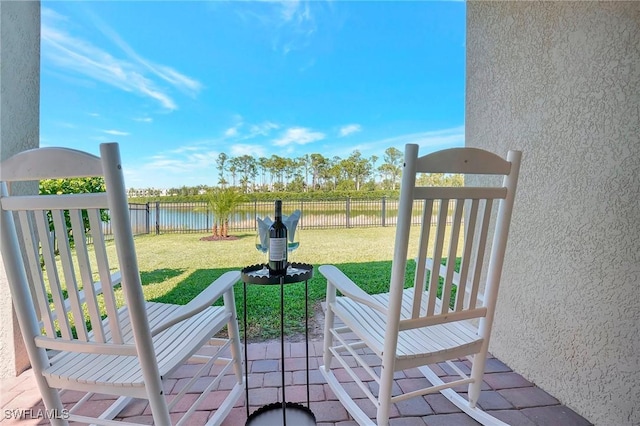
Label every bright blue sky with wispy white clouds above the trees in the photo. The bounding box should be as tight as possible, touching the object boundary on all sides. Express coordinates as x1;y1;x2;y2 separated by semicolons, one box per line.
40;0;465;188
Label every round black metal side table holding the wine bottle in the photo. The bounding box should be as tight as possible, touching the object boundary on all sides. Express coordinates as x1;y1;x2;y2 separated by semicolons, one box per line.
241;263;316;426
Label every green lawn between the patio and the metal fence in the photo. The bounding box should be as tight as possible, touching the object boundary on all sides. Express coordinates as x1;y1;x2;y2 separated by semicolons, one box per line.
94;227;456;340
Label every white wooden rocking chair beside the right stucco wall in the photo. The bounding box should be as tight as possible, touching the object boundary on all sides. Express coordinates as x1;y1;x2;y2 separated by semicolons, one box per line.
319;144;521;426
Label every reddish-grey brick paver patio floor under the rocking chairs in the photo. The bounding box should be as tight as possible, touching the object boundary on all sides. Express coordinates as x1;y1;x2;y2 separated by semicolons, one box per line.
0;341;590;426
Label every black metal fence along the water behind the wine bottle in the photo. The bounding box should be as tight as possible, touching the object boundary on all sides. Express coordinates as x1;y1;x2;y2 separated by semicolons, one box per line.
122;198;419;235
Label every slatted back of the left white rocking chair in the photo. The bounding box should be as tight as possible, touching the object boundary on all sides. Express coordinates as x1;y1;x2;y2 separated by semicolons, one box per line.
3;188;123;344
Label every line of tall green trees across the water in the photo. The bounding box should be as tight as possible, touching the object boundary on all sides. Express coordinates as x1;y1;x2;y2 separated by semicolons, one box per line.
129;147;463;196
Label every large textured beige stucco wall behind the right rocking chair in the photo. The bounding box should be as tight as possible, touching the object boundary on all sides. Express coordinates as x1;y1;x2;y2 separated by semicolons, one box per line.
465;2;640;426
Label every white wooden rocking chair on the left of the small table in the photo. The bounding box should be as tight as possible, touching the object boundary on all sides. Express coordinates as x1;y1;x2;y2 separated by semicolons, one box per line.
0;143;245;426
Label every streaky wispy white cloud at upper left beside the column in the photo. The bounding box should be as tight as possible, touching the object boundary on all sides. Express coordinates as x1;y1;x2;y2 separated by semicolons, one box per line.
41;8;202;110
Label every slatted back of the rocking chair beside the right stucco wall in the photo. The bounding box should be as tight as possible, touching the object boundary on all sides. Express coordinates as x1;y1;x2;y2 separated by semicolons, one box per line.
400;149;511;330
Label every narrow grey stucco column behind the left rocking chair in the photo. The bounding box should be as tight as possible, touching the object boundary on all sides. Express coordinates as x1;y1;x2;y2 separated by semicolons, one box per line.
0;1;40;377
